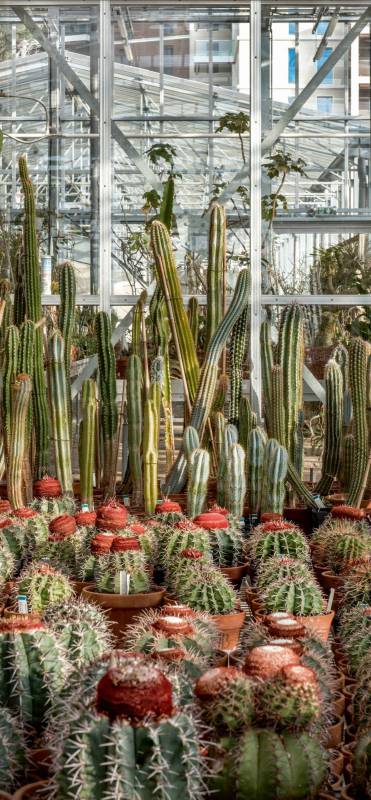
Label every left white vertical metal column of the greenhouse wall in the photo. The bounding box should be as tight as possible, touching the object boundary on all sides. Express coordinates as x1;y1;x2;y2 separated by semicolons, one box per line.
99;0;112;311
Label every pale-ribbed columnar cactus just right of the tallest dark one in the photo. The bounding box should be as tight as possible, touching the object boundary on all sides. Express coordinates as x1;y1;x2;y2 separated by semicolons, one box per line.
48;331;73;495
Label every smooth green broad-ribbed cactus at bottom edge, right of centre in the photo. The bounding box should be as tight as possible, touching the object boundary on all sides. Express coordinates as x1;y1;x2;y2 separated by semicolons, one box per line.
212;728;327;800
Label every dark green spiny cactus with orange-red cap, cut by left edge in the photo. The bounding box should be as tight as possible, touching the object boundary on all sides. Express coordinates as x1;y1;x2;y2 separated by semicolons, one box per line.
0;614;70;734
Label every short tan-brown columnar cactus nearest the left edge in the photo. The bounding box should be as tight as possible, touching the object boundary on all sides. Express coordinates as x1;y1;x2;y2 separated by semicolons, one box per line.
7;374;32;508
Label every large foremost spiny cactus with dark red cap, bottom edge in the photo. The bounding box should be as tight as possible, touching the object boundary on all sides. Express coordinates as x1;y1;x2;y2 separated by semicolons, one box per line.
54;656;205;800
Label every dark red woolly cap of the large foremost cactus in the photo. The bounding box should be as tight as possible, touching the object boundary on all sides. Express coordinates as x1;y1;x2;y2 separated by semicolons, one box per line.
97;659;174;724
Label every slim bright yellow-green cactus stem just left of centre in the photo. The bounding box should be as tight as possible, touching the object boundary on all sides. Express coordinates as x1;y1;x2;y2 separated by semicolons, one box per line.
143;400;158;515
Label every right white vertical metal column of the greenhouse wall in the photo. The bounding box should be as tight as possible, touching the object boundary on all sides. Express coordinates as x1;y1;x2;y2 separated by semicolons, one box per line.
250;0;262;420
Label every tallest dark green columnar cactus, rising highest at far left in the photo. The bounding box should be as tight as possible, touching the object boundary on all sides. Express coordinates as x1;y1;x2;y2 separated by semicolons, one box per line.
19;156;50;478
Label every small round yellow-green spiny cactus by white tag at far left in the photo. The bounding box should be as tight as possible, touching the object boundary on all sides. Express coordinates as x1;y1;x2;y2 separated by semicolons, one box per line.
15;562;73;614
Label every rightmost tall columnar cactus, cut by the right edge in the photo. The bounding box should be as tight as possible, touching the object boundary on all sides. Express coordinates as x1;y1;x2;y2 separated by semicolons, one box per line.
348;338;369;507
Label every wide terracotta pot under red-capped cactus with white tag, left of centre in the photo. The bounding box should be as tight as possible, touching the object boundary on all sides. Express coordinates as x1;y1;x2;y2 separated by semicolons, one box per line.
81;587;165;641
